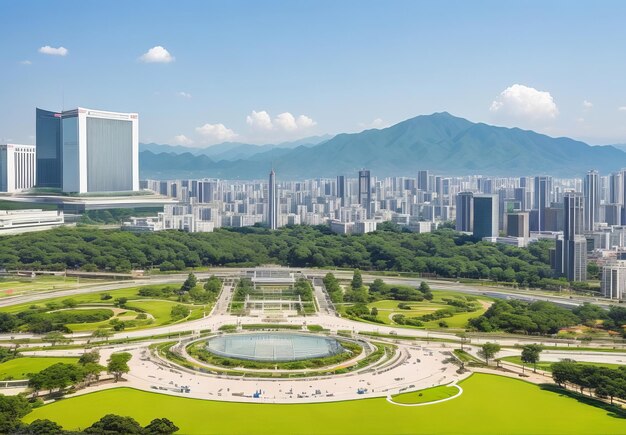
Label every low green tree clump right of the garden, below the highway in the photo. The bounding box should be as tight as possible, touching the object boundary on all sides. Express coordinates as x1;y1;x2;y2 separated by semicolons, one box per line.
469;300;626;335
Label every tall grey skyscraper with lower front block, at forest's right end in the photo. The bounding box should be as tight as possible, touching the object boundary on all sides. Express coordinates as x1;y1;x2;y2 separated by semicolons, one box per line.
555;192;587;281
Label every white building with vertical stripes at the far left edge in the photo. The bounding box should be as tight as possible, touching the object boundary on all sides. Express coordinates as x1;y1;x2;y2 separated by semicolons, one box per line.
0;144;36;193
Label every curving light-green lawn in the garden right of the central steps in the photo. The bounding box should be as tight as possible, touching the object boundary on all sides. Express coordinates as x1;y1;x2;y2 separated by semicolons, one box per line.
368;290;492;329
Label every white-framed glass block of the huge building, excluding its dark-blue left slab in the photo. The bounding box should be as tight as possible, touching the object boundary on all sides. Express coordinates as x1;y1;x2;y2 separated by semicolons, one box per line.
61;107;139;193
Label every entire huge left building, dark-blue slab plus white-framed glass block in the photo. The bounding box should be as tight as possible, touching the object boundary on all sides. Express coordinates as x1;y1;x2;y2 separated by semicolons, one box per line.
36;107;139;193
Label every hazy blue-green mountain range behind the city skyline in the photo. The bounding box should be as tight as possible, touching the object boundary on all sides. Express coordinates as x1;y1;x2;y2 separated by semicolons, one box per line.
139;112;626;180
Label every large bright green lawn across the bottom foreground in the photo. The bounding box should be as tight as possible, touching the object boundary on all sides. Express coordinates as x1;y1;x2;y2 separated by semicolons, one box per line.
23;374;626;435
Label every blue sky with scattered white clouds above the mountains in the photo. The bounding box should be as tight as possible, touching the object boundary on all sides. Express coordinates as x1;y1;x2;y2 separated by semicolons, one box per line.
0;0;626;146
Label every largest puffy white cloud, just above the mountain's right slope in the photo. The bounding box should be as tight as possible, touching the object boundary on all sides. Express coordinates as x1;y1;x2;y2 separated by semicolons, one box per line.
489;84;559;121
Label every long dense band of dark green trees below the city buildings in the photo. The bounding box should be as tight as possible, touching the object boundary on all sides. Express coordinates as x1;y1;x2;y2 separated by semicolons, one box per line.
0;226;564;286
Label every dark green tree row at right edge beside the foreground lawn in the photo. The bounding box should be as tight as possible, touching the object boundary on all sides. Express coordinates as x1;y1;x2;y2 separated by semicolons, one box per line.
552;360;626;403
